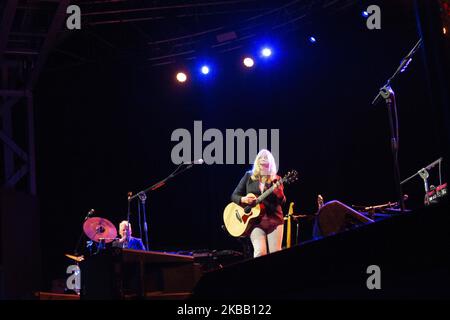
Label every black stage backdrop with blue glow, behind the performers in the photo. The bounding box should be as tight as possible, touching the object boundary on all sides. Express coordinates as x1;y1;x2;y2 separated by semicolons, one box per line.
35;2;441;286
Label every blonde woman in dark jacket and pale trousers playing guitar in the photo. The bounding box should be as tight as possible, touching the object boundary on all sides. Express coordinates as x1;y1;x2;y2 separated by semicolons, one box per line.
231;149;286;257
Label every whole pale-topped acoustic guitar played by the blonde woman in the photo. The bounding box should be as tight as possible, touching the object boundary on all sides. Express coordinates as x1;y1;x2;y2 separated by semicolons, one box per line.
223;170;298;237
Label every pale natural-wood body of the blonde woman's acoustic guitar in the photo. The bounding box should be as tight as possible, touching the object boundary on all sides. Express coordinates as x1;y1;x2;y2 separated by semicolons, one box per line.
223;193;261;237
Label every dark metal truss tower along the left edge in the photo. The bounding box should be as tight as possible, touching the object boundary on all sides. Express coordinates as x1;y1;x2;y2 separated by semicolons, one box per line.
0;0;69;195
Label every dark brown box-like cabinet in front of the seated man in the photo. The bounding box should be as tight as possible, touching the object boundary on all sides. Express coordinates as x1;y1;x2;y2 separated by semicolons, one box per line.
80;248;202;300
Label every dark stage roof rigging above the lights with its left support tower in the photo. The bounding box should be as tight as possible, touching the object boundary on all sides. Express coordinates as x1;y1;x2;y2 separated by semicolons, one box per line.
0;0;357;194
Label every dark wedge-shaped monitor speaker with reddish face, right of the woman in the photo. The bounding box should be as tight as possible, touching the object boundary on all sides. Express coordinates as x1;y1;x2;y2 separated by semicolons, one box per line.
315;200;373;237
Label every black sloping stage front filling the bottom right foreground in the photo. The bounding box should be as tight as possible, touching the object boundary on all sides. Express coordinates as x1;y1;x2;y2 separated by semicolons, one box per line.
192;205;450;299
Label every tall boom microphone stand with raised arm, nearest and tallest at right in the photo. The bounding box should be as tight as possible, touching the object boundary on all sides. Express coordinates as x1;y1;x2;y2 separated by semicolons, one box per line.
372;39;422;213
